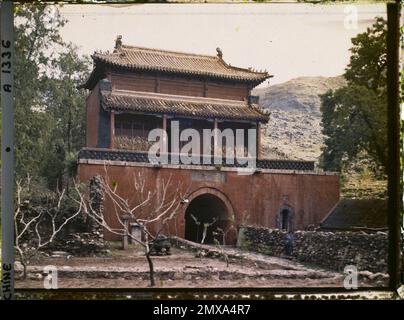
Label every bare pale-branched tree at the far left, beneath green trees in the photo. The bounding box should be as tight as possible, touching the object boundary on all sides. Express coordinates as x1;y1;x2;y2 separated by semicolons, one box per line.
14;176;82;279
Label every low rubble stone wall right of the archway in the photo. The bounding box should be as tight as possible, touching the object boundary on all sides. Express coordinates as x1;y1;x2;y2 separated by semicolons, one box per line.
238;226;388;273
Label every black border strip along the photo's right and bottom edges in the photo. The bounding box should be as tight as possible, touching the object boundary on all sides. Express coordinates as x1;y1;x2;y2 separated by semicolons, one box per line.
1;0;404;299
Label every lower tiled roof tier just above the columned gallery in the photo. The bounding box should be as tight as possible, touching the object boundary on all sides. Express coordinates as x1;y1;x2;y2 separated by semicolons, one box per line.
101;90;269;122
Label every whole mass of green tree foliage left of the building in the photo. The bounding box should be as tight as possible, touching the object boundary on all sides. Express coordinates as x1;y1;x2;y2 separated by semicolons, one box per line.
10;4;89;188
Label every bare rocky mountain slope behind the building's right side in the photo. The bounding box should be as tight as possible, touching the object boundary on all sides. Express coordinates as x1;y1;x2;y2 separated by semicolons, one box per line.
252;76;345;162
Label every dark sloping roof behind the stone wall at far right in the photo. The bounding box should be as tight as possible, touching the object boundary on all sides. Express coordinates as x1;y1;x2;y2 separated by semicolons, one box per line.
320;199;387;230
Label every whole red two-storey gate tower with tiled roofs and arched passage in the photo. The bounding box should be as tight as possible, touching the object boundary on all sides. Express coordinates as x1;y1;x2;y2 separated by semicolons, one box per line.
78;37;339;244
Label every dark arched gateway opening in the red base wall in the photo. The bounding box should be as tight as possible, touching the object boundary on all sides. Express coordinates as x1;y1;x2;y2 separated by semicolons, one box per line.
184;188;234;244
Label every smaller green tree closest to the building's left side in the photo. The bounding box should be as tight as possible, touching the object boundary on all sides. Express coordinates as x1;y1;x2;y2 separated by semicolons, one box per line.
42;44;90;187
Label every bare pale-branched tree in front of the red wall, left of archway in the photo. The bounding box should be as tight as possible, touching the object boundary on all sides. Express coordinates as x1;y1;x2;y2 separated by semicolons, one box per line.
76;169;184;286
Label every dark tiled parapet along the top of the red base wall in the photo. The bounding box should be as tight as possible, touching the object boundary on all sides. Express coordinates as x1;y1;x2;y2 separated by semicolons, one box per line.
78;148;314;171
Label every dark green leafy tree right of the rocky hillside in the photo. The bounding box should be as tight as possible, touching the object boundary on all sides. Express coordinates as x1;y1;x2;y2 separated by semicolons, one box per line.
320;18;387;173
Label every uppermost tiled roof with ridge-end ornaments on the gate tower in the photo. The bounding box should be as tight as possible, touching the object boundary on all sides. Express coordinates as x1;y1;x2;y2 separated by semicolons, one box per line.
82;37;271;89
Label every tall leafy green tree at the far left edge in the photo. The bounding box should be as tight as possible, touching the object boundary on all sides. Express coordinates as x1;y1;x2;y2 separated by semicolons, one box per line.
14;5;65;177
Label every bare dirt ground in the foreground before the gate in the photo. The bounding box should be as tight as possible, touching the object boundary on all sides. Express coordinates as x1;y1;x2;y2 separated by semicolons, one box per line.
16;242;387;288
